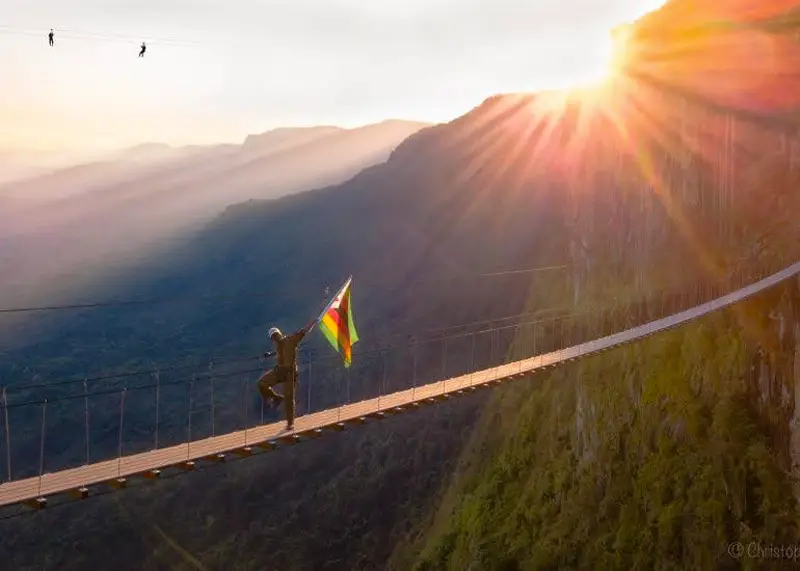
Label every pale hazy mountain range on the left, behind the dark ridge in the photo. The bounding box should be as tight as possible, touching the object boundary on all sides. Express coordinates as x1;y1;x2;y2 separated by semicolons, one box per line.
0;120;426;310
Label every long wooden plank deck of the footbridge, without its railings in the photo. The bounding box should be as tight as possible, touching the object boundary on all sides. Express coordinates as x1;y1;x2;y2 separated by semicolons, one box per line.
0;262;800;507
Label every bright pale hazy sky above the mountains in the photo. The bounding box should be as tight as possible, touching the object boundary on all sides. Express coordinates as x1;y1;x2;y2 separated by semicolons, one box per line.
0;0;663;152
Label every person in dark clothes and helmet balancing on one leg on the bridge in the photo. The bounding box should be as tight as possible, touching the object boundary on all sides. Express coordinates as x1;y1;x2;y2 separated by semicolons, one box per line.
258;324;311;430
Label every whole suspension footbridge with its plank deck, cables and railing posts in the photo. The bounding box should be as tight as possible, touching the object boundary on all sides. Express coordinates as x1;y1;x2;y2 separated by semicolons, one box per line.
0;262;800;510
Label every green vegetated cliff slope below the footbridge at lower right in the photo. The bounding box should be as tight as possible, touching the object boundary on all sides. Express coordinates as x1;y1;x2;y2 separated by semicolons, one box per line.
416;274;800;569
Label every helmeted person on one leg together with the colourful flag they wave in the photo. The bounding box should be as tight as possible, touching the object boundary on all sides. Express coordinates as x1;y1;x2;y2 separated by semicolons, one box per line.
257;277;358;430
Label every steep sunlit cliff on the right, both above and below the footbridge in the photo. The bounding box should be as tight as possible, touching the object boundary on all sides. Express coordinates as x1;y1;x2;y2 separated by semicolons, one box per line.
400;2;800;569
